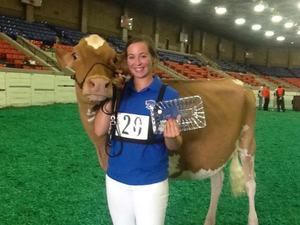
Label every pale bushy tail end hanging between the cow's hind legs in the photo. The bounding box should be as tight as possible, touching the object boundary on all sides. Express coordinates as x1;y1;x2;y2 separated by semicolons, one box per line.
230;142;245;197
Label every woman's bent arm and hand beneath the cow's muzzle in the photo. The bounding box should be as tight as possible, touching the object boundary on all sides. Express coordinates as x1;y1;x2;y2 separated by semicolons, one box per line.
95;101;111;137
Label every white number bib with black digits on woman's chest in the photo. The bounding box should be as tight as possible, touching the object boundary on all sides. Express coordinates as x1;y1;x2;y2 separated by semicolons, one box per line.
115;113;149;140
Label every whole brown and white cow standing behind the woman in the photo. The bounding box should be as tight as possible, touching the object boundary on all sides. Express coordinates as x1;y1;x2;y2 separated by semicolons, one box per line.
55;35;258;225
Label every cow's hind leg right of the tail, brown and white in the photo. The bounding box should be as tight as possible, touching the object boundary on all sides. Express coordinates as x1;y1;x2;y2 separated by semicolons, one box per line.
240;139;258;225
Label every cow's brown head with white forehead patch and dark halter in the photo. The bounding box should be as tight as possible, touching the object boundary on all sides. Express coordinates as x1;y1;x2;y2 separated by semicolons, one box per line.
55;34;124;102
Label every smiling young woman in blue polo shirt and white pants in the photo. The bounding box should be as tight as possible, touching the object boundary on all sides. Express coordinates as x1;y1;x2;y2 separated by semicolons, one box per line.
95;36;182;225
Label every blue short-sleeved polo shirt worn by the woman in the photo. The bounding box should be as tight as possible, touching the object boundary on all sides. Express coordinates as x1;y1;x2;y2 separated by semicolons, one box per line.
107;76;179;185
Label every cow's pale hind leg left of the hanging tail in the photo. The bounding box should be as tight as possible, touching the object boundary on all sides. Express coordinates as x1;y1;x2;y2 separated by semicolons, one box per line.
204;170;224;225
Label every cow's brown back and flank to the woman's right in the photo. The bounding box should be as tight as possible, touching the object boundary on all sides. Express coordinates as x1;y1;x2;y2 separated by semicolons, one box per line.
164;79;255;173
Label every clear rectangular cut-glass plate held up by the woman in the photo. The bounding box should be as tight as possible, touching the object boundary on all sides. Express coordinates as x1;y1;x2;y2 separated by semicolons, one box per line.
150;95;206;134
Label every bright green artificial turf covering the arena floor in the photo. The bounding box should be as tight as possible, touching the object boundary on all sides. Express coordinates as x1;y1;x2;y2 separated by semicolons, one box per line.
0;104;300;225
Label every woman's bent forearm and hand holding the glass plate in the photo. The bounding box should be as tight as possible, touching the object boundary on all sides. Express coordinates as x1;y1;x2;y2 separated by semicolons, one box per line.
164;115;182;150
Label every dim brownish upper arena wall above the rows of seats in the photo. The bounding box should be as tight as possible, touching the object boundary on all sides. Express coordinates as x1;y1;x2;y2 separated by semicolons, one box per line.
0;0;300;67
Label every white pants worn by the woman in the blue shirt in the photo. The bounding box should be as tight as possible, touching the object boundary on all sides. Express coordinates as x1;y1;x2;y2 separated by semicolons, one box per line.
106;175;169;225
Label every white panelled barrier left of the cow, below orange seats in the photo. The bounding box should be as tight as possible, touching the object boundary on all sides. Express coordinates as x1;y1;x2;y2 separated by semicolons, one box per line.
0;72;77;108
